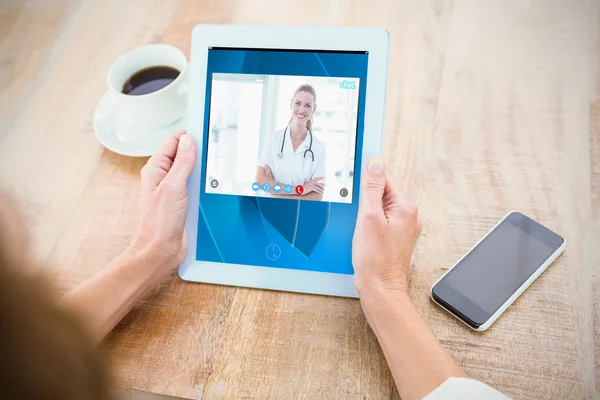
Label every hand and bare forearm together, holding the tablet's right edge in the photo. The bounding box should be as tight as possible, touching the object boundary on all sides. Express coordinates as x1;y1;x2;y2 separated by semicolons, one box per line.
352;157;466;399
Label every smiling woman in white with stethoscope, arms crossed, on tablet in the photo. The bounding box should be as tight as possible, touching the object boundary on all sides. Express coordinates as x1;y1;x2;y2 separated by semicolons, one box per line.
256;84;325;200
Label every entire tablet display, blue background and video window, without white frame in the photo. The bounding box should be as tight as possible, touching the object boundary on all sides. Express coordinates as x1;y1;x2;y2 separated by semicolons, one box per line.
196;48;368;274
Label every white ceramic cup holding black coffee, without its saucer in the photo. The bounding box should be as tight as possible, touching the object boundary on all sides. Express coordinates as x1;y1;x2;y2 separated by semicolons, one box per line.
106;44;188;131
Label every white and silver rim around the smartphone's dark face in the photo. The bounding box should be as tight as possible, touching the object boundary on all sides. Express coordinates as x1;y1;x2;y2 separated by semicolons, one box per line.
429;210;567;332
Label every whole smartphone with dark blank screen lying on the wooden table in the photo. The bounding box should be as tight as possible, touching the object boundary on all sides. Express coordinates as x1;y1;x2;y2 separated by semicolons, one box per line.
431;211;566;331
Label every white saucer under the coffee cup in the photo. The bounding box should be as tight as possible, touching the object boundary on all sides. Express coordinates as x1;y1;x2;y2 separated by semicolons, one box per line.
94;91;186;157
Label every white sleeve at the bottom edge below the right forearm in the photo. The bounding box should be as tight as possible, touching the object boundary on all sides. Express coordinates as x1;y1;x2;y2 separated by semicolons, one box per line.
423;378;510;400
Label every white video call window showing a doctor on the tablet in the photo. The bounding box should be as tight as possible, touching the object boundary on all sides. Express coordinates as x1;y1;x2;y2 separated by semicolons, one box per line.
205;73;360;203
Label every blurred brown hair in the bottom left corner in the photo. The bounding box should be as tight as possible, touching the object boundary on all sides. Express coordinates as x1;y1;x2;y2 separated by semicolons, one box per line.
0;199;112;400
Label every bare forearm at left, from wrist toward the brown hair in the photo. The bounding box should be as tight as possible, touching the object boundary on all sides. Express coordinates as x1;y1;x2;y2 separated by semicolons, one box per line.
63;250;166;342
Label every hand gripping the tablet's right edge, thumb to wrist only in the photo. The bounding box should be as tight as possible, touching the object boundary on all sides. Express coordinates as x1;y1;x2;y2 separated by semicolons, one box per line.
352;157;421;297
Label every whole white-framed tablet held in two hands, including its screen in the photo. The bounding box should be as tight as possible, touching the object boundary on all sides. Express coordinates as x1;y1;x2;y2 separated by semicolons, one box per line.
179;25;389;297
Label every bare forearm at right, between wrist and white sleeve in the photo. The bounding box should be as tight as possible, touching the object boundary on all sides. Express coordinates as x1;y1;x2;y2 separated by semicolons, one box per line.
361;289;466;399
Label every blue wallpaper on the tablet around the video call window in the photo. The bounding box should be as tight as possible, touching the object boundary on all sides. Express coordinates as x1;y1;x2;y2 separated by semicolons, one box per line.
196;48;368;274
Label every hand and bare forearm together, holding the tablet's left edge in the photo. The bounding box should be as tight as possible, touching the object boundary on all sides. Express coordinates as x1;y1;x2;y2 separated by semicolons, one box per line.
63;131;196;342
